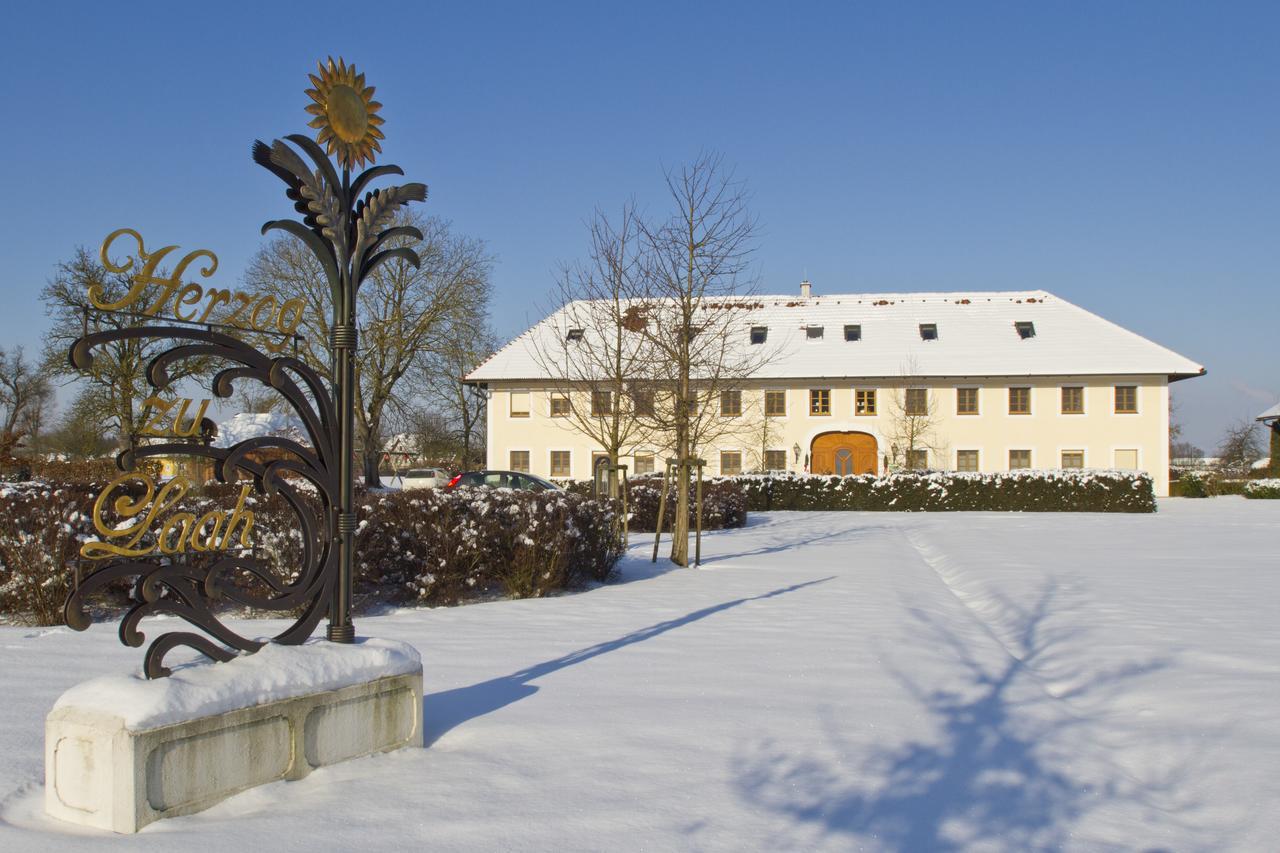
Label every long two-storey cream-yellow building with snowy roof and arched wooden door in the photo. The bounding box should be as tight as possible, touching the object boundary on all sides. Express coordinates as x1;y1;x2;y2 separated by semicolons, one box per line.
467;284;1204;496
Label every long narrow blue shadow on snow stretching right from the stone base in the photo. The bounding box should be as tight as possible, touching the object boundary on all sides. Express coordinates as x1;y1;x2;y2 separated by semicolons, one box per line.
422;578;832;745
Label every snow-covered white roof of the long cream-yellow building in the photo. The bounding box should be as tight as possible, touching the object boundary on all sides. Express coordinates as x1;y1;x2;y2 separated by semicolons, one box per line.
467;291;1204;382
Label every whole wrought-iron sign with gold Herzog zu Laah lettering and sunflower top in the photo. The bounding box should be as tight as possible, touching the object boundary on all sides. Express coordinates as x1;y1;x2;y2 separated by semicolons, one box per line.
65;58;426;678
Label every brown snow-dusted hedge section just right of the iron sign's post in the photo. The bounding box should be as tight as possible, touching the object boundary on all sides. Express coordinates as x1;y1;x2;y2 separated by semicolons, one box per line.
356;488;622;605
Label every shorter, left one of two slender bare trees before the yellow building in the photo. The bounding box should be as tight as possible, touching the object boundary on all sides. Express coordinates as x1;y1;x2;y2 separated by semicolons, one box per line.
534;202;650;497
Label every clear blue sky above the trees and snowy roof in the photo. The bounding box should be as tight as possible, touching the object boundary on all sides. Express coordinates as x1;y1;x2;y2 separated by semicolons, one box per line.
0;3;1280;450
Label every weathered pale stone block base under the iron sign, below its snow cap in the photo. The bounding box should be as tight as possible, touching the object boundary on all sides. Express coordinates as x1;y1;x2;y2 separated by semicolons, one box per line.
45;665;422;833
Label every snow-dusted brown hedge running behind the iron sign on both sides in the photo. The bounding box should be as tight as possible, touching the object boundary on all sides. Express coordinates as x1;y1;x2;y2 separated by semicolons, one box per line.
0;471;623;625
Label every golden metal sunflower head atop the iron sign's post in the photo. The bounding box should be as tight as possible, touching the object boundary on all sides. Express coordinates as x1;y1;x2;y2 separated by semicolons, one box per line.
307;56;385;169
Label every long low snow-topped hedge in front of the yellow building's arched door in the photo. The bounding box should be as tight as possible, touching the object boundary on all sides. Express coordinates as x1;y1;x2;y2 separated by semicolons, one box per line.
733;470;1156;512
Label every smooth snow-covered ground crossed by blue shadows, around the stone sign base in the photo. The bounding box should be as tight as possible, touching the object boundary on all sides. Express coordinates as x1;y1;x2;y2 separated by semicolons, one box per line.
0;498;1280;853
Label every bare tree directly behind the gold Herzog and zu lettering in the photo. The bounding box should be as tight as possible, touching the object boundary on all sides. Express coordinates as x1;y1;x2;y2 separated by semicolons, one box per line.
41;247;210;443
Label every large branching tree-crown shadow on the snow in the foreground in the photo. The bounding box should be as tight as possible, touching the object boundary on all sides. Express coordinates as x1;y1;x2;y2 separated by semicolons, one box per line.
733;583;1196;852
